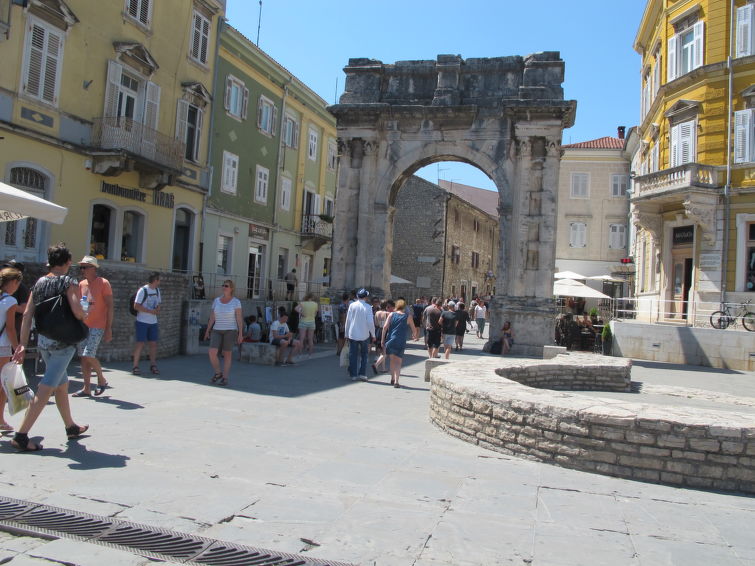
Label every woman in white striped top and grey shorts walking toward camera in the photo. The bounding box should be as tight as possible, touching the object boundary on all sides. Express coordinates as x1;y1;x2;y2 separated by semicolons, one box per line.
204;279;244;386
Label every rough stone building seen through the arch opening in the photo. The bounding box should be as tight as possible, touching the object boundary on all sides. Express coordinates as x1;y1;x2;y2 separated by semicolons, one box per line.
391;177;498;301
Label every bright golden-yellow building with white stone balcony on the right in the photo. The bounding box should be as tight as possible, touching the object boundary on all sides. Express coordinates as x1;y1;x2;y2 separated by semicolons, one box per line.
631;0;755;323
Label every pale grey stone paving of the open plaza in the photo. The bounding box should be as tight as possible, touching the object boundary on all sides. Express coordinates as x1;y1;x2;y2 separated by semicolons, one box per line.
0;335;755;566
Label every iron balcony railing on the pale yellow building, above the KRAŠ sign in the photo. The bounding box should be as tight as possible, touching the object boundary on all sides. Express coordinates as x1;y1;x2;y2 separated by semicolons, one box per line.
92;118;184;171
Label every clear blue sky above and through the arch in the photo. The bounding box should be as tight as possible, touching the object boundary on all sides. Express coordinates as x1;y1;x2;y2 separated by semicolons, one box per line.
226;0;645;192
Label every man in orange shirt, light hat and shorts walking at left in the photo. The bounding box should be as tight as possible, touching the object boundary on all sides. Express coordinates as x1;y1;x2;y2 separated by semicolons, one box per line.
73;255;113;397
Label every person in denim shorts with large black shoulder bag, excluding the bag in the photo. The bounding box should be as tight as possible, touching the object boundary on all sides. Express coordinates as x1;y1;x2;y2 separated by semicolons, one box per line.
11;243;89;452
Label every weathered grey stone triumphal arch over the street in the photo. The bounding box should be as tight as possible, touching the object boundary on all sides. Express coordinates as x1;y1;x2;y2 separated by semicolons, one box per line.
330;52;576;354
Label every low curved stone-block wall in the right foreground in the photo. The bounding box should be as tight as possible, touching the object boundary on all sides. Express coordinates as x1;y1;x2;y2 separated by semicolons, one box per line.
430;355;755;493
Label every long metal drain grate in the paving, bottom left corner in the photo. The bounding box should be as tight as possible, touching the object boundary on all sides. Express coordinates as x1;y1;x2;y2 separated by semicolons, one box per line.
0;497;354;566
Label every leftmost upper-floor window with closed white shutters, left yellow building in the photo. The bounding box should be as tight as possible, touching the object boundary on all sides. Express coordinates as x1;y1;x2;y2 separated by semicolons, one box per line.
22;16;63;106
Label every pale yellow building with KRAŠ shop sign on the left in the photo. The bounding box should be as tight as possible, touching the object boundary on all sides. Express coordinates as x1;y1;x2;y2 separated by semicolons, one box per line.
0;0;225;271
